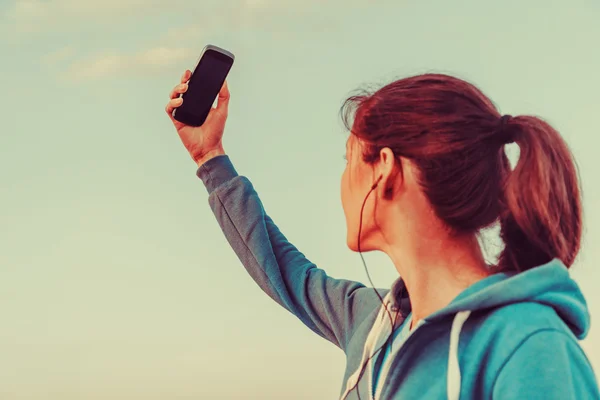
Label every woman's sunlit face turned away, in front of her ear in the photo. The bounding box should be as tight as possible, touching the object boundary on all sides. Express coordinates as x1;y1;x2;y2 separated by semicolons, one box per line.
341;134;375;251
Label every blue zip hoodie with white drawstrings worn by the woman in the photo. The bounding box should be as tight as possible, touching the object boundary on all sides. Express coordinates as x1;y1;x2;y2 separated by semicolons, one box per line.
197;156;600;400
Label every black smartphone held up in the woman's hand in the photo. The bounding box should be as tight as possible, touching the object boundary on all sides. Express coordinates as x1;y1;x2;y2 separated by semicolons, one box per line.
173;45;235;126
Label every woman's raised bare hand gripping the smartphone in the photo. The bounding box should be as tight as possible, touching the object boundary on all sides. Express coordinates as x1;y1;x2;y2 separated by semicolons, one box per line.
165;70;229;166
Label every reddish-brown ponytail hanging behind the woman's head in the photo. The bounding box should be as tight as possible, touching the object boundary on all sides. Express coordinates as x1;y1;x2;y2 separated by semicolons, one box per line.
498;116;582;271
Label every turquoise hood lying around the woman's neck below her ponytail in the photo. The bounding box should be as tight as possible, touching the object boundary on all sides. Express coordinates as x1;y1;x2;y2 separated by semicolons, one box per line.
392;259;590;340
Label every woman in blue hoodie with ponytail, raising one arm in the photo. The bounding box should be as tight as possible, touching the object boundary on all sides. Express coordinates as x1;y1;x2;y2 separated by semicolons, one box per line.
166;71;600;400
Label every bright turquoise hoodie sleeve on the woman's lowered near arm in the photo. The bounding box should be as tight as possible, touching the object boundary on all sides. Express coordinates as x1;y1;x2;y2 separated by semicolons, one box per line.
493;330;600;400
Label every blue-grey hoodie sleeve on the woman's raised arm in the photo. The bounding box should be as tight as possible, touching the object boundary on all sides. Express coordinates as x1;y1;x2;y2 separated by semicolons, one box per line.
197;156;375;350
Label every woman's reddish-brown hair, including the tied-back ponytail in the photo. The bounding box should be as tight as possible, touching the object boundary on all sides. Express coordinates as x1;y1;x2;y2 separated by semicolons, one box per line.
341;74;582;271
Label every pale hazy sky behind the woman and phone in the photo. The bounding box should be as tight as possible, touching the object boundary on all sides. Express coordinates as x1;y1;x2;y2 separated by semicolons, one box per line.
0;0;600;400
